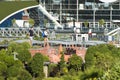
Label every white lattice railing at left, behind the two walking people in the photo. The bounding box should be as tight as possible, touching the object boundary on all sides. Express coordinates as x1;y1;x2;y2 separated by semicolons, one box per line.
0;27;42;37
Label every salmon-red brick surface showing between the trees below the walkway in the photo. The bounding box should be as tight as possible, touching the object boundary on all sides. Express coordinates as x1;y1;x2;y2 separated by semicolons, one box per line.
29;47;86;63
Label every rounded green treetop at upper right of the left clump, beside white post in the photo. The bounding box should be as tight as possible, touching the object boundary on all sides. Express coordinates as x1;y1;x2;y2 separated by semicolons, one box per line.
8;42;31;63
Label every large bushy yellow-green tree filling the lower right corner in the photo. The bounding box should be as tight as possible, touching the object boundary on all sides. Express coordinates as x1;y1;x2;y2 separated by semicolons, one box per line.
86;44;120;80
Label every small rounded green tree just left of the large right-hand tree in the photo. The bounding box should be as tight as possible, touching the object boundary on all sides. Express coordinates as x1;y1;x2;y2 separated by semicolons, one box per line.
69;54;82;71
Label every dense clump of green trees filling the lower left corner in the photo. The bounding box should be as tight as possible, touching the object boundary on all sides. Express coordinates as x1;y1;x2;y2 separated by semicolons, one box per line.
0;43;32;80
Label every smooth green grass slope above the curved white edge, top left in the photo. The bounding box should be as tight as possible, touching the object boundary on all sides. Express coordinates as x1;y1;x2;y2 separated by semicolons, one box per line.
0;1;38;21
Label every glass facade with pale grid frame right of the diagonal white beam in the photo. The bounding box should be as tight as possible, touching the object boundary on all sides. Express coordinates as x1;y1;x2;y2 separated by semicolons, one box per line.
42;0;120;27
